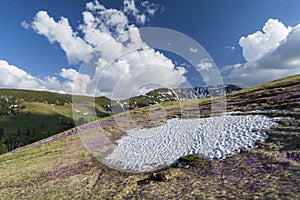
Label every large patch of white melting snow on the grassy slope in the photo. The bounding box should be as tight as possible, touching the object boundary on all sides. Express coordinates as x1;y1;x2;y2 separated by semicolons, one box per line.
103;114;284;172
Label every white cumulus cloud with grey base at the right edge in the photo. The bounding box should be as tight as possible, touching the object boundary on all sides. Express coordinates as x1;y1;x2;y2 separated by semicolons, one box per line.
222;19;300;86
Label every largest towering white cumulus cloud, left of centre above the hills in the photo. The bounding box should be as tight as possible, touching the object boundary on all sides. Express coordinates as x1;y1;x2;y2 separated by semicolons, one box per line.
18;0;186;99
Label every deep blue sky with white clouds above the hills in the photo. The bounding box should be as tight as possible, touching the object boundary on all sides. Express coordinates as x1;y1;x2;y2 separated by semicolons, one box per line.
0;0;300;99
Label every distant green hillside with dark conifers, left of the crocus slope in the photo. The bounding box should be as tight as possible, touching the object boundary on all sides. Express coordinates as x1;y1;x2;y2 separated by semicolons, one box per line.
0;89;110;154
